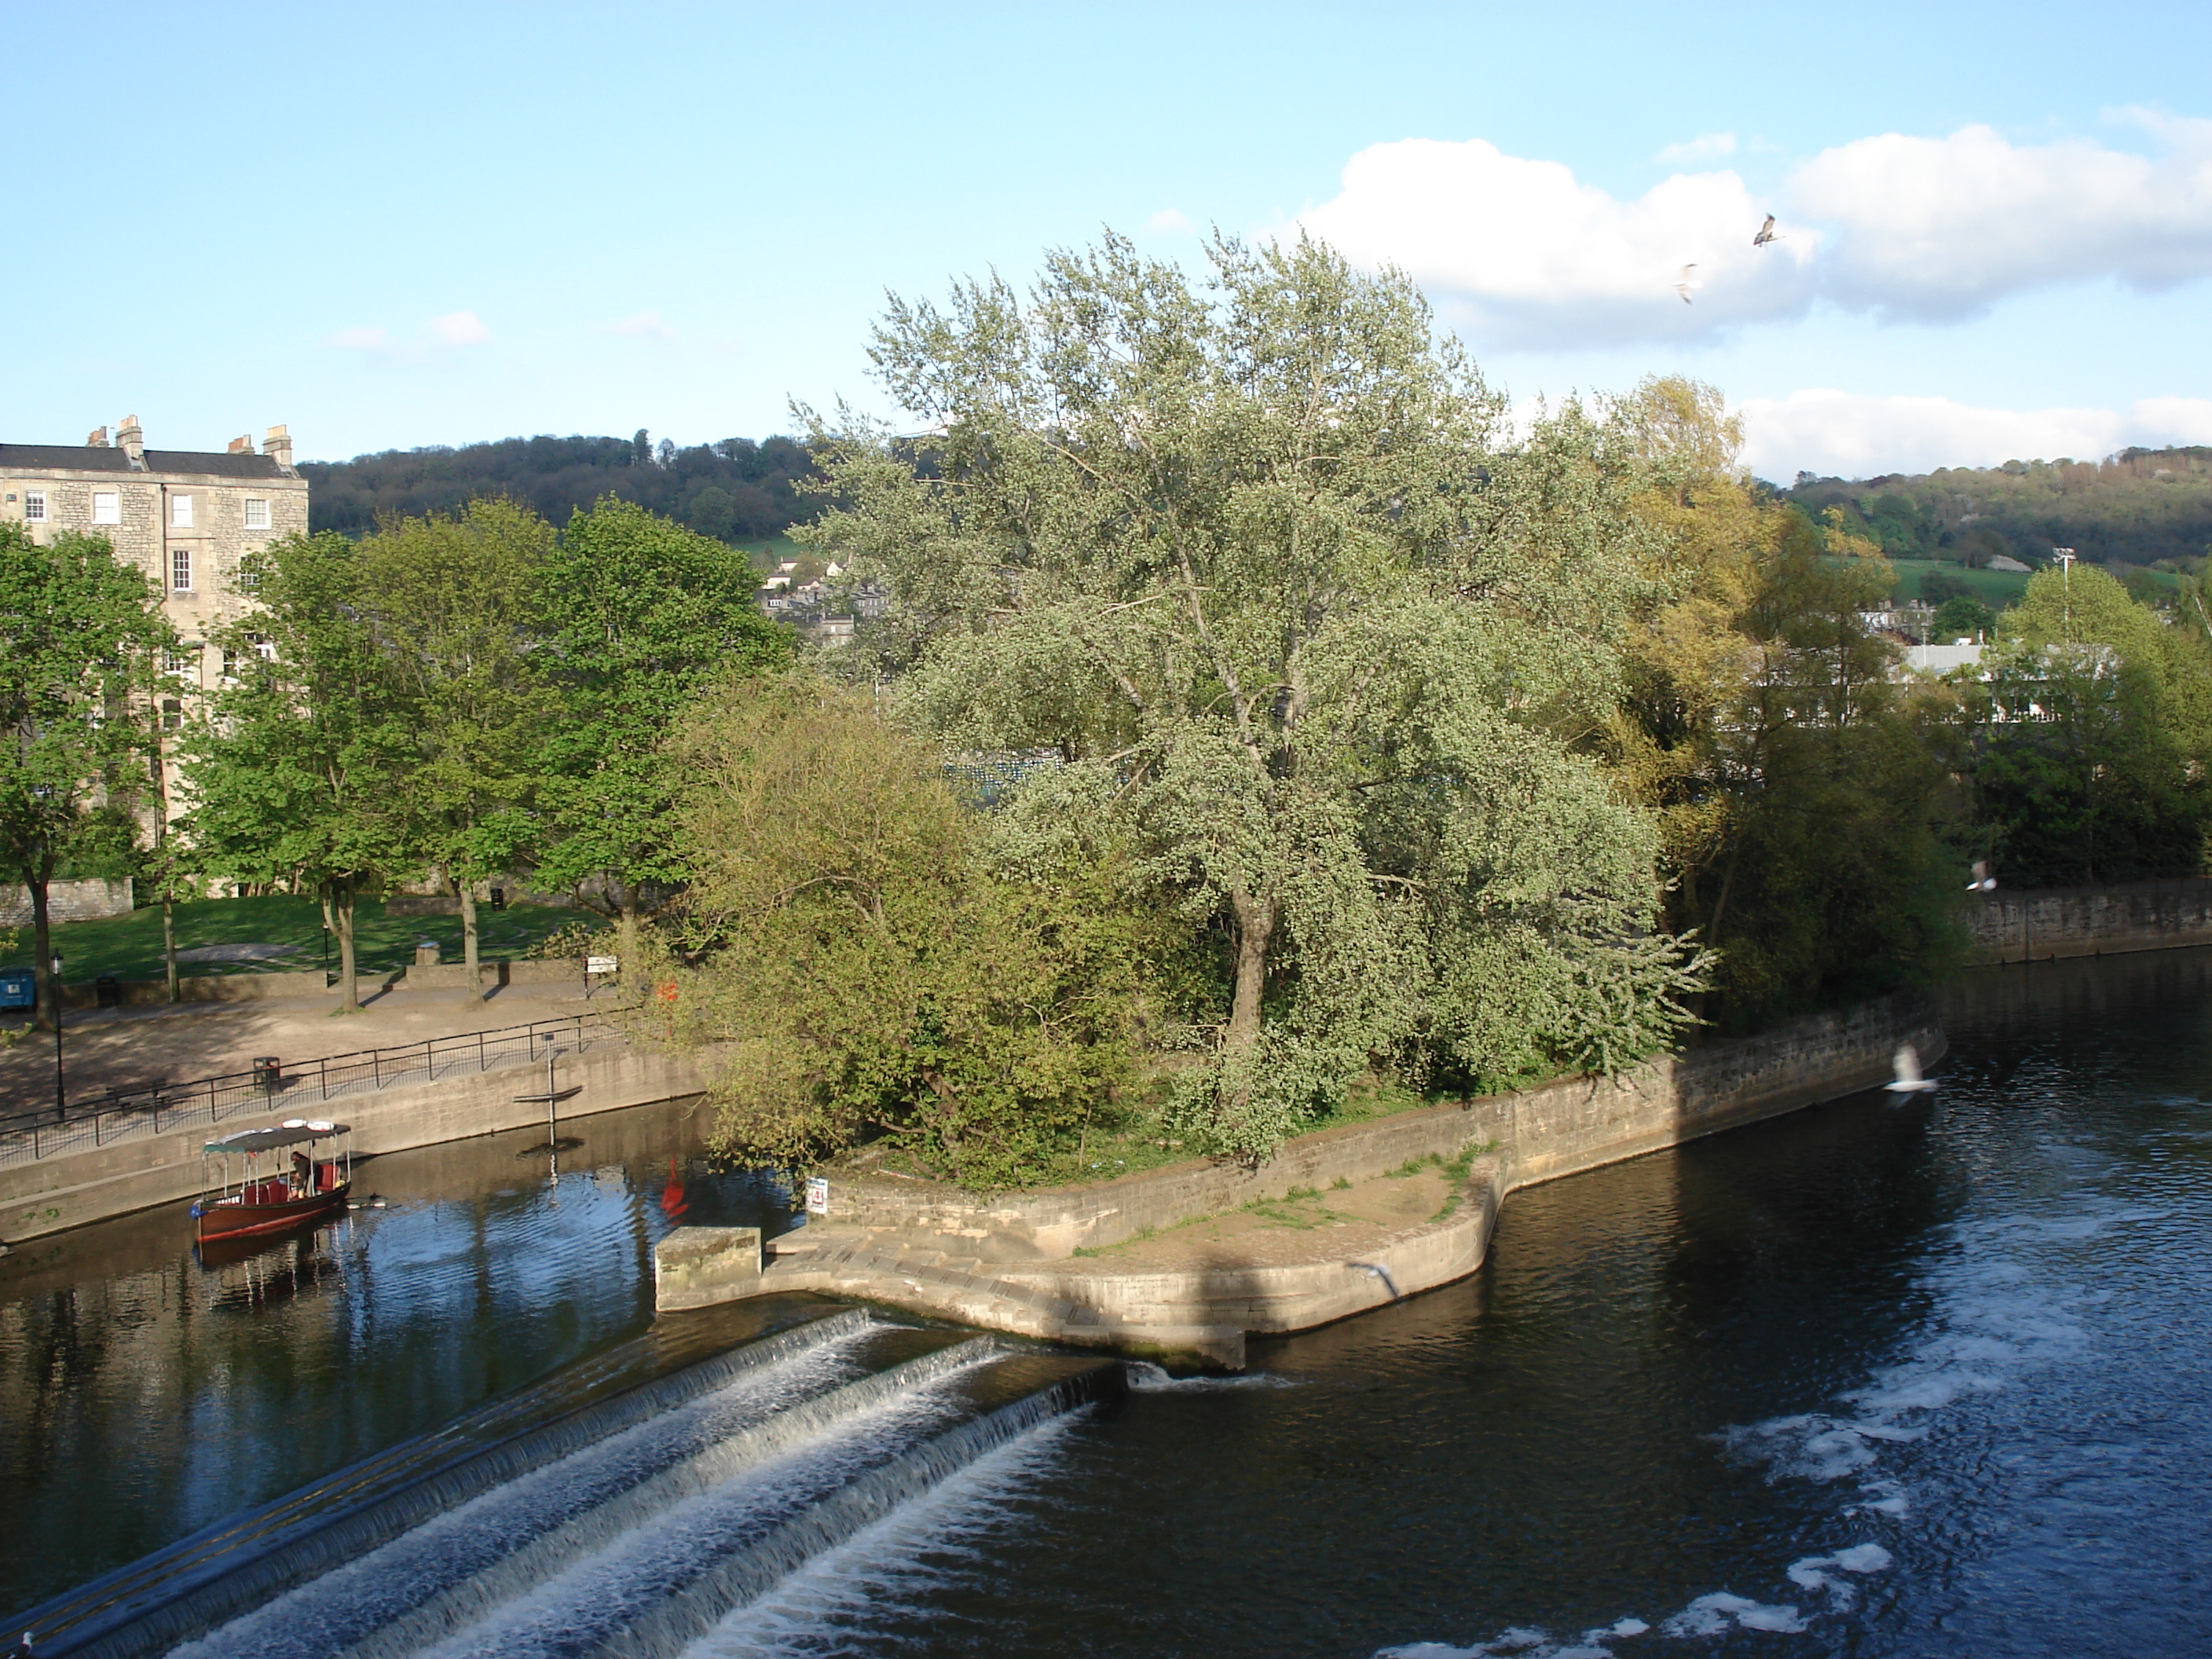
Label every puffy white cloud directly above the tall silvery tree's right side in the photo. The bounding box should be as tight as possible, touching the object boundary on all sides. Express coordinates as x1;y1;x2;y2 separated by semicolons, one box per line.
1301;139;1818;345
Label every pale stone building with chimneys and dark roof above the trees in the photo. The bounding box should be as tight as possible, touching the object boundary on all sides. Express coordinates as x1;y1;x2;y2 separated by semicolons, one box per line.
0;416;307;688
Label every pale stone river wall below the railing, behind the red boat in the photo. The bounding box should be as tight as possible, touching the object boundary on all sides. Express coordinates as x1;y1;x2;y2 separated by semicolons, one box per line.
0;1042;699;1243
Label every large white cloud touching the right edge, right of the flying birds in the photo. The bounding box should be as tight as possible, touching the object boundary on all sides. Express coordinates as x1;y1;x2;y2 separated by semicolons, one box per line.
1789;117;2212;320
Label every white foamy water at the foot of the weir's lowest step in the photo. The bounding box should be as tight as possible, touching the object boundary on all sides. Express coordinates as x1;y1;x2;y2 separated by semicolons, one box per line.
683;1412;1088;1659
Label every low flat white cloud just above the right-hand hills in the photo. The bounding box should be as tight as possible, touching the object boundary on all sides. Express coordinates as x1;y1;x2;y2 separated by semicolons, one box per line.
1738;390;2212;482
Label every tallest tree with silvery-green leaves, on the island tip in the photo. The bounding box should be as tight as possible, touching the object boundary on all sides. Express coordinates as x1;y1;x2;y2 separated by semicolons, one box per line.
814;239;1688;1155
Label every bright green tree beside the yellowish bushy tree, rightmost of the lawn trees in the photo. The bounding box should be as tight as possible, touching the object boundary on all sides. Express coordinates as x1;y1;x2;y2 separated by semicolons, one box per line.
537;497;794;956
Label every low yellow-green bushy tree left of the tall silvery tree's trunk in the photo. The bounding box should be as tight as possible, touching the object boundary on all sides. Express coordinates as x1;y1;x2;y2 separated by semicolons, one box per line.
672;675;1172;1185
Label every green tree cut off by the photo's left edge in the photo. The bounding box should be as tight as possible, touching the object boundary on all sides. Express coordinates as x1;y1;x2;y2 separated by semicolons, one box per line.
0;522;174;1022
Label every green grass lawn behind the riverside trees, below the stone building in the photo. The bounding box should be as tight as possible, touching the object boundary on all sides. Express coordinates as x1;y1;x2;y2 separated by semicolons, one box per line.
0;898;588;984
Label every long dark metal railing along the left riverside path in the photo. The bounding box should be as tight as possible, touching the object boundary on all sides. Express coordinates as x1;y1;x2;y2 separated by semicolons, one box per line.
0;1013;628;1163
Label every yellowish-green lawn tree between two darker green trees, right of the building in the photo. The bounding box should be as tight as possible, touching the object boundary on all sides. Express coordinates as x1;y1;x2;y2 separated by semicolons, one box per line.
358;500;553;984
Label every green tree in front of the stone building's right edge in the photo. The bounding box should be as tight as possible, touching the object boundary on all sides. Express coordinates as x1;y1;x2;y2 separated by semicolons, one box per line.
186;531;423;1013
